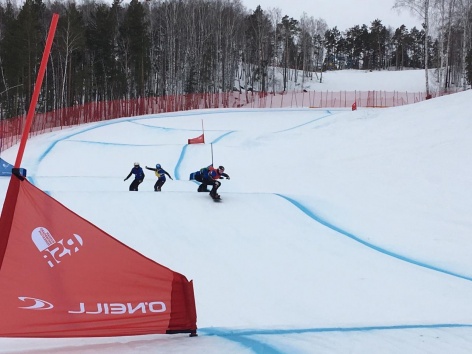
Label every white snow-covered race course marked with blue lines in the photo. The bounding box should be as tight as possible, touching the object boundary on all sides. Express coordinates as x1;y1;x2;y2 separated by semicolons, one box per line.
0;71;472;354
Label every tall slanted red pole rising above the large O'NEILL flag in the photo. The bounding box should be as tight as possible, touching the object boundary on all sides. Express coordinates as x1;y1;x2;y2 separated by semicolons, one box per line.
14;14;59;168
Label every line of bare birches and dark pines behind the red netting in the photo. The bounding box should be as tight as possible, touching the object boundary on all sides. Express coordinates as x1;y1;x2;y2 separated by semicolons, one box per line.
0;0;472;118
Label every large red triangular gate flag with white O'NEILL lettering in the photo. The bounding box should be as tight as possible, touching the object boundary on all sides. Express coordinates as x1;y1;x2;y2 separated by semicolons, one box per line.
0;175;197;337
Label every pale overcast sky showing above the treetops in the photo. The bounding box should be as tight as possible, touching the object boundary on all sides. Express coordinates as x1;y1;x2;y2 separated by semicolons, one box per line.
242;0;421;31
